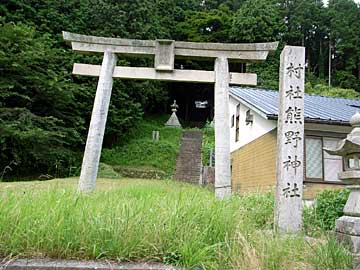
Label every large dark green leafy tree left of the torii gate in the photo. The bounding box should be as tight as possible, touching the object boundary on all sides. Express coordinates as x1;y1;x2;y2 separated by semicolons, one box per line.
0;23;84;174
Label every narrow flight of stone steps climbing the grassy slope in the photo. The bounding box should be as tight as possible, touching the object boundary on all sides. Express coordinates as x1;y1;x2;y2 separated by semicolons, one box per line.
173;131;203;184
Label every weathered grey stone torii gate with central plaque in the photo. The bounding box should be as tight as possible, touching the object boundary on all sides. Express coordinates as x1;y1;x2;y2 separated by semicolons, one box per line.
63;32;278;198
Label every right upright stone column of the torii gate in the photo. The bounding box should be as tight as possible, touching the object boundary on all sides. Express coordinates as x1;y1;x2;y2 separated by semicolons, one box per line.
214;57;231;199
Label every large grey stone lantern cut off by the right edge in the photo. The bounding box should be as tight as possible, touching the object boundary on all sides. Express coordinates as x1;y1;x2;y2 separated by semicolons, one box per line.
324;112;360;269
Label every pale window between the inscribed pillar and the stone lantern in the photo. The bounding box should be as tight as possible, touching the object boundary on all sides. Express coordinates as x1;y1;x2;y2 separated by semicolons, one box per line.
305;136;343;181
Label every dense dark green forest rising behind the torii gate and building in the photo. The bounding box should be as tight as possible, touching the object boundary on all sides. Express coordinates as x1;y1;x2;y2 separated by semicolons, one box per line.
0;0;360;176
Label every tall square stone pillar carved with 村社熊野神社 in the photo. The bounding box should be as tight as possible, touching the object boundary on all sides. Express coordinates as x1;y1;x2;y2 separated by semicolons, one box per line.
275;46;305;233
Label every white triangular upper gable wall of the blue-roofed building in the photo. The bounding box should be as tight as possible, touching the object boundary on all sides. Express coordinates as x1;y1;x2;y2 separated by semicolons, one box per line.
229;96;277;152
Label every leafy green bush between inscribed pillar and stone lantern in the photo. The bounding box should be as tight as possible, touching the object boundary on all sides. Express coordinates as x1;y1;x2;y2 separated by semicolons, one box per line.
304;189;350;230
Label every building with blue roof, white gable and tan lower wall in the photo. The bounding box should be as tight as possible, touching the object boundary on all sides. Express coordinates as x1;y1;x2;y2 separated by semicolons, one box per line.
229;87;360;199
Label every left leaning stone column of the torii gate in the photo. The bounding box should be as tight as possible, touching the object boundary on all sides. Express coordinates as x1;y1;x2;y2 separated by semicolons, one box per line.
78;51;117;192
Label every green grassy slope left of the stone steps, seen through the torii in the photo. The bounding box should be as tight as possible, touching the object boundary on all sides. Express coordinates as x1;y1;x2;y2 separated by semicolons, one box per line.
101;116;182;176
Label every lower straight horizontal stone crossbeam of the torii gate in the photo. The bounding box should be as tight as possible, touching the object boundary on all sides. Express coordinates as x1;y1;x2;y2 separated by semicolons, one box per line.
73;63;257;85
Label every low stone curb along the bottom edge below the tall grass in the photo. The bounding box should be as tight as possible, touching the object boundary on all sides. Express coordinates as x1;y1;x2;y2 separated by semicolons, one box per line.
0;259;177;270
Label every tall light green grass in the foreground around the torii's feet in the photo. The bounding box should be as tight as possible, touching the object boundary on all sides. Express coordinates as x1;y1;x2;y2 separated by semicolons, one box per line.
0;179;351;270
